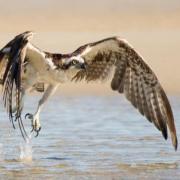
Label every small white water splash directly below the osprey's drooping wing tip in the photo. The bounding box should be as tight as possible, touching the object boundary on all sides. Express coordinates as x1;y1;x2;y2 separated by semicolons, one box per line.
19;135;33;162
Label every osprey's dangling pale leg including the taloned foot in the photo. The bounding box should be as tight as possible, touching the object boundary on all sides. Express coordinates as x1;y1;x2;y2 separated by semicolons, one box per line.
25;84;58;137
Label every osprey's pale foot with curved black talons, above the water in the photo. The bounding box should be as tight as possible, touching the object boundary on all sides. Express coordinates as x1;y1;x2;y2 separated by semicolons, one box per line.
25;113;41;137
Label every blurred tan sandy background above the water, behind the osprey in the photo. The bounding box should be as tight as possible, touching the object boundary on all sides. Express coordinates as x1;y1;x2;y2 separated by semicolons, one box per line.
0;0;180;95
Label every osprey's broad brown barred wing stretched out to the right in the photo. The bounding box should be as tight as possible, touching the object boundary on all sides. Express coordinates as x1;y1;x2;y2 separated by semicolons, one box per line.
71;37;178;149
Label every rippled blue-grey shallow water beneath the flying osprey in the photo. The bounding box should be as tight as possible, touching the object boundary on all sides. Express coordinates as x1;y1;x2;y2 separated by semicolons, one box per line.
0;96;180;179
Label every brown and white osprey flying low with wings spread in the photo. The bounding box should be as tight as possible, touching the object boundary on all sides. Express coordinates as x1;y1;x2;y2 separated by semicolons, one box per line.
0;31;178;149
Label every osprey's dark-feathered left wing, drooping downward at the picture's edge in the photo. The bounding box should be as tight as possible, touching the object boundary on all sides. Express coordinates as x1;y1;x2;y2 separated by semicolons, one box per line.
0;32;32;139
